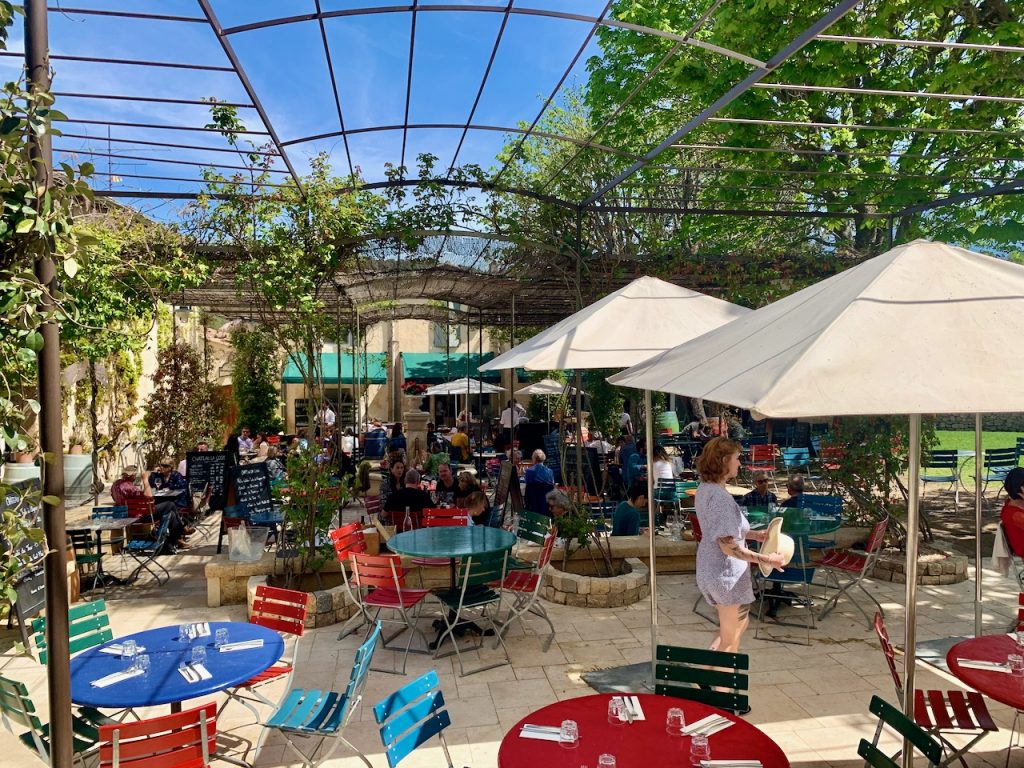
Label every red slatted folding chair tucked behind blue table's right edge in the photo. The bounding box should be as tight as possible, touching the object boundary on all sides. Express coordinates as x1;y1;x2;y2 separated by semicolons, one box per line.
217;584;308;724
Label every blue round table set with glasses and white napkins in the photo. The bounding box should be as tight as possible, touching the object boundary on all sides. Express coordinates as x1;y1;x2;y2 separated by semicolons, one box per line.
71;622;285;710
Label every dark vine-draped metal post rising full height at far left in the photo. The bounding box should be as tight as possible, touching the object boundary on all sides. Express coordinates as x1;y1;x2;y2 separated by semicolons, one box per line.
25;0;74;768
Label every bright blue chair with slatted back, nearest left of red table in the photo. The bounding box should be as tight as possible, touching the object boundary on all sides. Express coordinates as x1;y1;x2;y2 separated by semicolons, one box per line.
374;670;454;768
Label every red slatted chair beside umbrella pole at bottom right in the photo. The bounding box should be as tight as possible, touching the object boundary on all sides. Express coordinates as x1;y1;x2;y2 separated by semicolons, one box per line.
874;613;998;768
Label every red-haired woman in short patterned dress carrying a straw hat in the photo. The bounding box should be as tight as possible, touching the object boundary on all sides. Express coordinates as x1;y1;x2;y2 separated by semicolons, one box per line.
694;437;784;667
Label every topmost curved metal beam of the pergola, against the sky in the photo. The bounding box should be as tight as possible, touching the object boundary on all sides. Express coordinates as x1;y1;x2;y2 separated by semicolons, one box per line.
223;3;765;68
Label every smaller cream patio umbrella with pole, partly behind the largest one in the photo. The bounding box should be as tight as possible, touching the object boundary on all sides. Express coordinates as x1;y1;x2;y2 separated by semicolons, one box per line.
480;276;751;682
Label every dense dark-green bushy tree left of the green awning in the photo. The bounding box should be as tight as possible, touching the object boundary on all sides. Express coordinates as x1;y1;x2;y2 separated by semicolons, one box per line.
231;327;282;434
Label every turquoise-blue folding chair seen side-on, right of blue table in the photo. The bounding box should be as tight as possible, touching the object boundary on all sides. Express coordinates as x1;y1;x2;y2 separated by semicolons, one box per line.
257;623;381;768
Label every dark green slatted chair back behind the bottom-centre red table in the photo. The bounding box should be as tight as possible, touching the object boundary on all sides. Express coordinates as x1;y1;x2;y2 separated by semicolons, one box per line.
654;645;751;715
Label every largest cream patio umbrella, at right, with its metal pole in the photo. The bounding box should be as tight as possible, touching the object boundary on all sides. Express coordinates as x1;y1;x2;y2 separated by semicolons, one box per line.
608;240;1024;741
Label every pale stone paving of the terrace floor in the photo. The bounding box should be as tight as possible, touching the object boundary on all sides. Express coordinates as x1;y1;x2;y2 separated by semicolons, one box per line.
0;518;1024;768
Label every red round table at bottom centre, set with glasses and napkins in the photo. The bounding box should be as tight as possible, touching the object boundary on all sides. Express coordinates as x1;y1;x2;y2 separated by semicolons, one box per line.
498;693;790;768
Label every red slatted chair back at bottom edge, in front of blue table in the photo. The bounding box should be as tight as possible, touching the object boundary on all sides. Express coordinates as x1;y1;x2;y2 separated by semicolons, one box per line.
99;701;217;768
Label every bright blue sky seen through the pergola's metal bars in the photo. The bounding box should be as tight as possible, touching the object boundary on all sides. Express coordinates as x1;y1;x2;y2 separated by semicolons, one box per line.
0;0;604;216
